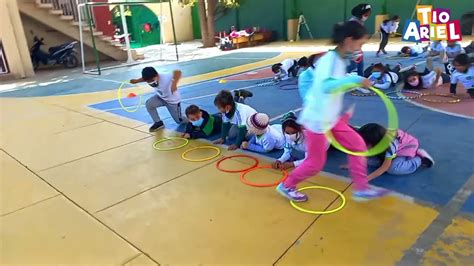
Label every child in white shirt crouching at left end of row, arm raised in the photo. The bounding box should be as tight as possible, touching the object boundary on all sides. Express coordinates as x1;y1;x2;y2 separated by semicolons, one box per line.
130;67;185;132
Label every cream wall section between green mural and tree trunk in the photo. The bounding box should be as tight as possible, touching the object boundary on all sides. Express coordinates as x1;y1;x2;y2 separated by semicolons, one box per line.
145;1;194;43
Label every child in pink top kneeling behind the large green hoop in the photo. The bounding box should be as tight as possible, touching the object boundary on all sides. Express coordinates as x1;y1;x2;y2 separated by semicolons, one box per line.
358;123;434;180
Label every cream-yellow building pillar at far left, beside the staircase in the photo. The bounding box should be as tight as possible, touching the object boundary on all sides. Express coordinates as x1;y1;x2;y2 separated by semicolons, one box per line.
0;1;34;79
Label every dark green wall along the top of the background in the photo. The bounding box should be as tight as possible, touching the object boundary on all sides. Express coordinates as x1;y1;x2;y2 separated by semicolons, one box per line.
216;0;474;40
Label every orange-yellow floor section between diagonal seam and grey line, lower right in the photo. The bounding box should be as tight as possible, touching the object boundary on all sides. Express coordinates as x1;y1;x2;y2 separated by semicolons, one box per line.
278;189;438;266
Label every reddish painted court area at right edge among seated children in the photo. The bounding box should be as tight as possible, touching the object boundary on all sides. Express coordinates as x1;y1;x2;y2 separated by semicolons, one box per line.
407;83;474;118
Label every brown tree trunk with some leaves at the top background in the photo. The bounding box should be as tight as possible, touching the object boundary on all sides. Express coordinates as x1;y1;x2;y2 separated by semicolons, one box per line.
178;0;239;47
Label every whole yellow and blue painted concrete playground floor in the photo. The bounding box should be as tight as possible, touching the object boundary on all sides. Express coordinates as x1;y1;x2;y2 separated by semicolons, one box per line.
0;40;474;265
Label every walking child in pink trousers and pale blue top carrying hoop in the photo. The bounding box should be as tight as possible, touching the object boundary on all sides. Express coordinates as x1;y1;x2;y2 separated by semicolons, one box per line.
276;21;387;202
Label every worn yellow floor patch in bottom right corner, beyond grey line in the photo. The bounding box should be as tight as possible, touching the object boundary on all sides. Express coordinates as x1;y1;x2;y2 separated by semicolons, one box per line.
422;217;474;266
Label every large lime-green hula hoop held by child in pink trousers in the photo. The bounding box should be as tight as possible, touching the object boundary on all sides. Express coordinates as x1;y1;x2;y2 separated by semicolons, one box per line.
325;83;398;157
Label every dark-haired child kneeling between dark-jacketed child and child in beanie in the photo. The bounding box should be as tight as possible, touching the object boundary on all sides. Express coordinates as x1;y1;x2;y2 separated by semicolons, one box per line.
214;90;257;151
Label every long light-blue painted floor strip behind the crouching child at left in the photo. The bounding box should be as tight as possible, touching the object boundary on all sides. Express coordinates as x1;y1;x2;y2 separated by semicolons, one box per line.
0;52;280;97
